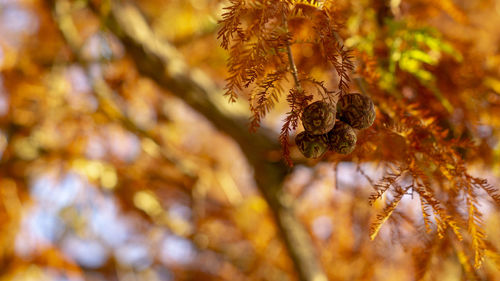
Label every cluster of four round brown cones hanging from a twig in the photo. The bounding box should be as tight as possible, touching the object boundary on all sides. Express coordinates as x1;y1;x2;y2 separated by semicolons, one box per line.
295;93;375;158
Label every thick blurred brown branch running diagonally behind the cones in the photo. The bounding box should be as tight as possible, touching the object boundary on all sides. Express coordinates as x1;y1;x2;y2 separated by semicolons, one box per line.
84;1;327;281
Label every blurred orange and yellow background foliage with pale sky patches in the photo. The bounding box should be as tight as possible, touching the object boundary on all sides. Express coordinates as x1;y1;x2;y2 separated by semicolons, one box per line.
0;0;500;281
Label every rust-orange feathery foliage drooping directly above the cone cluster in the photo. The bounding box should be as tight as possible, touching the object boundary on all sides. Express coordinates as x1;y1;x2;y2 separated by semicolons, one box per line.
218;1;354;165
